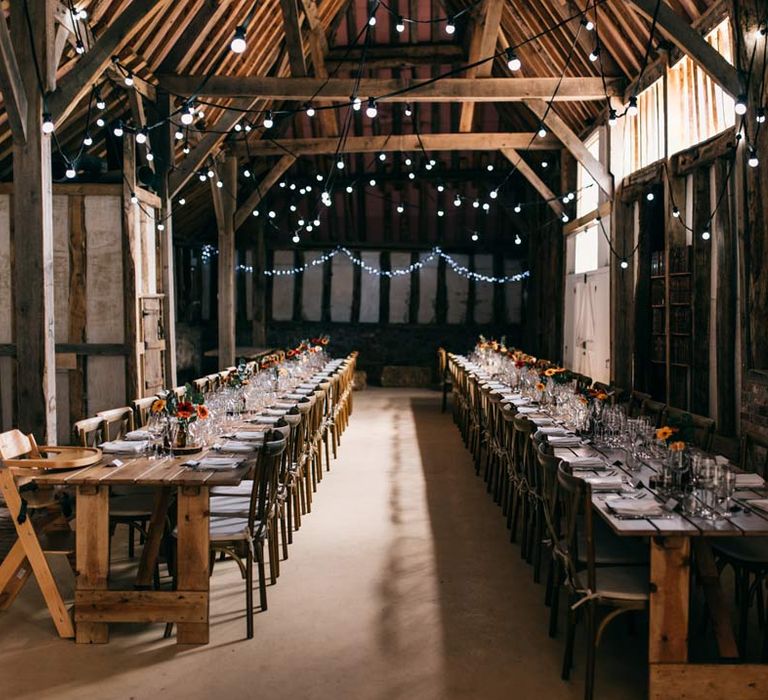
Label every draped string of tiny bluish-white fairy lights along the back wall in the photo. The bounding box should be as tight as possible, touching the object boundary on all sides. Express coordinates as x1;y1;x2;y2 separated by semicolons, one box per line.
200;245;531;284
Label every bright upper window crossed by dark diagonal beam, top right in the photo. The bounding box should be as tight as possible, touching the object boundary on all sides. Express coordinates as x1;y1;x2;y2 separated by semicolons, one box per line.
668;18;736;153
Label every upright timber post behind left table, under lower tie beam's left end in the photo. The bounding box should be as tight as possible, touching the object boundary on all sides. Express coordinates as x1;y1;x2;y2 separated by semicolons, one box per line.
214;153;237;367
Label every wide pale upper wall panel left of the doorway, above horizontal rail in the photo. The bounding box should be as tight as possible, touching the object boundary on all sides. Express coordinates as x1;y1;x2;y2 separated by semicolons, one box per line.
85;195;124;344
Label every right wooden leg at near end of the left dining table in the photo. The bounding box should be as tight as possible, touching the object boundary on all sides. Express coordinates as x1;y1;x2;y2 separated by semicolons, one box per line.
176;486;210;644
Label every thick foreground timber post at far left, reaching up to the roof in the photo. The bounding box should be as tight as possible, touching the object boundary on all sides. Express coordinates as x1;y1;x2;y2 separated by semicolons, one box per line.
10;0;56;444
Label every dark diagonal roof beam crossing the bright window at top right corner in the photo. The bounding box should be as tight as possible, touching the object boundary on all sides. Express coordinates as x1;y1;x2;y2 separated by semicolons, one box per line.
627;0;744;98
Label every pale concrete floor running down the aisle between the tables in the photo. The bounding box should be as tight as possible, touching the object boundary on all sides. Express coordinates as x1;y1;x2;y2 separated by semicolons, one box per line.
0;388;646;700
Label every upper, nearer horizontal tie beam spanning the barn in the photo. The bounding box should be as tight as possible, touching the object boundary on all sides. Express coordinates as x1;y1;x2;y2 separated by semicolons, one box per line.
159;75;621;102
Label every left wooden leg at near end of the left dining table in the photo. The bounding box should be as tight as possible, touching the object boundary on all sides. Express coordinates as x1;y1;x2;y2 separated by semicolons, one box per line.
75;485;109;644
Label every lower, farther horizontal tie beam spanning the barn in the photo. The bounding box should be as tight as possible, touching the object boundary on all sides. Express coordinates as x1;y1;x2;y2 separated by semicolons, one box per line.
238;133;560;157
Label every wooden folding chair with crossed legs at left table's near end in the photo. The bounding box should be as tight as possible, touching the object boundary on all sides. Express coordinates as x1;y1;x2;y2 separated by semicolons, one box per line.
0;430;75;637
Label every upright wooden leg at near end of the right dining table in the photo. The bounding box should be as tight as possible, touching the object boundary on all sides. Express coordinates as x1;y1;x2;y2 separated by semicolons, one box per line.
648;537;691;698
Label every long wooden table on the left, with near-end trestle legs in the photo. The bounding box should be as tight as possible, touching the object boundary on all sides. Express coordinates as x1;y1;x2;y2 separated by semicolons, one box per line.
25;455;252;644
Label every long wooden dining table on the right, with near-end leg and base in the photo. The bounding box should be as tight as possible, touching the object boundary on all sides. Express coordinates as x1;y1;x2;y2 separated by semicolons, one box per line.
555;447;768;700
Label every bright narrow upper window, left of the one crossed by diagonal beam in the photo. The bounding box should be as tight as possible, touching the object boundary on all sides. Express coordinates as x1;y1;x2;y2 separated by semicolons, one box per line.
624;78;664;175
